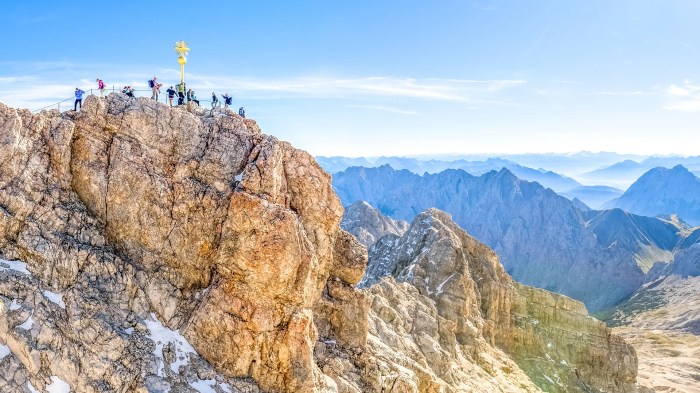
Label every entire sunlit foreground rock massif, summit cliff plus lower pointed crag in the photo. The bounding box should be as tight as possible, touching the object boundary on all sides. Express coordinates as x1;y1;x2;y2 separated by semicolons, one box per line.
0;93;652;393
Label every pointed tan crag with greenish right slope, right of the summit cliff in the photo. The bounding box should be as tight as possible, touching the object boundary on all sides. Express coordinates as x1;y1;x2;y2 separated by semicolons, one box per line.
368;209;652;392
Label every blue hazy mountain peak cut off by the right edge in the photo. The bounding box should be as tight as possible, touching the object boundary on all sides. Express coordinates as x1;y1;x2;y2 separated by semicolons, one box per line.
605;165;700;225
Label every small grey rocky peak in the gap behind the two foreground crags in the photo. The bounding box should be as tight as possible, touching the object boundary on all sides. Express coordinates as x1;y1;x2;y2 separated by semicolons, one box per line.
340;201;408;248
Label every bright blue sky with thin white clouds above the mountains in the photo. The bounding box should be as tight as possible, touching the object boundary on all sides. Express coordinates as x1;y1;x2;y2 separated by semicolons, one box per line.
0;0;700;156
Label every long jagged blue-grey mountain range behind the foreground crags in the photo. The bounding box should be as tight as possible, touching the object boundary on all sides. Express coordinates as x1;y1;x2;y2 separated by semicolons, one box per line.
333;165;698;310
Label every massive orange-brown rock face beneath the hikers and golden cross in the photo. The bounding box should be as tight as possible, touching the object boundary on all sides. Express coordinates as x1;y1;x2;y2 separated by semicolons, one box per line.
0;94;367;392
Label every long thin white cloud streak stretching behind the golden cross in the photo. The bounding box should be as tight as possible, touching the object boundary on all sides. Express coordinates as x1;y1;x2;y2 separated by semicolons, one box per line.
0;61;526;114
